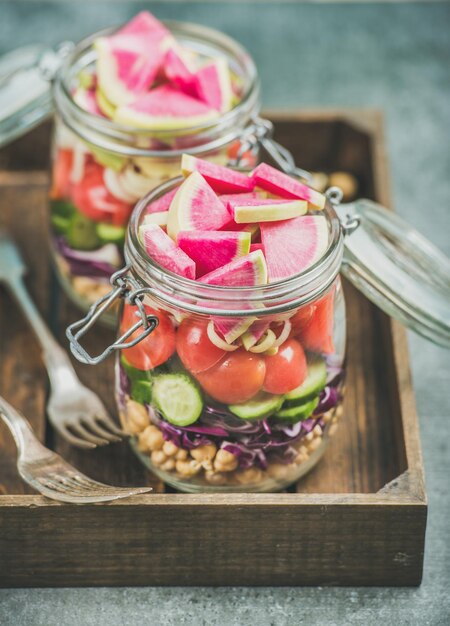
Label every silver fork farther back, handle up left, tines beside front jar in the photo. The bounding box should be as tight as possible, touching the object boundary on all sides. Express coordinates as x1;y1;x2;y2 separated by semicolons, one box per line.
0;231;126;448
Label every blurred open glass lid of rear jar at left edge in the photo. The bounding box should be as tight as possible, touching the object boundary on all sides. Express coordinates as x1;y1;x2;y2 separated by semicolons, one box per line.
0;43;72;147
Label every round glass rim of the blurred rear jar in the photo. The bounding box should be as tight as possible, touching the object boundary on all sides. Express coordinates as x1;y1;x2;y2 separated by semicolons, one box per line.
54;20;260;158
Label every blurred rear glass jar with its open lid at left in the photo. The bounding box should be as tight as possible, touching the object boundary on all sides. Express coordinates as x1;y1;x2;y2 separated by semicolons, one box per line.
0;22;264;325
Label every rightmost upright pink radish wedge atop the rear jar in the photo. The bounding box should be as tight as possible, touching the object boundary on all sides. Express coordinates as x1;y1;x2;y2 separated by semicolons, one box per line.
194;57;233;113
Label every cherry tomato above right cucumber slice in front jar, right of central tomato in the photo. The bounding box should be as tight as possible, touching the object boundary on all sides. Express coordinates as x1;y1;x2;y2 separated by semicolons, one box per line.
264;339;308;394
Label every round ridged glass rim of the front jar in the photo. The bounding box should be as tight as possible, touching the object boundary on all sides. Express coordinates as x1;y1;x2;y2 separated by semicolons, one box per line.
125;176;344;317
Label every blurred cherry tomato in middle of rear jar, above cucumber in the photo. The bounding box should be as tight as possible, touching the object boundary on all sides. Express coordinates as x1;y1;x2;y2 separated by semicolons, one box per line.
72;163;132;226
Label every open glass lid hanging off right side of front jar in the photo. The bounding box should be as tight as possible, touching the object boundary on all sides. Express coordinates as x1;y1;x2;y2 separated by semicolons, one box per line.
329;196;450;347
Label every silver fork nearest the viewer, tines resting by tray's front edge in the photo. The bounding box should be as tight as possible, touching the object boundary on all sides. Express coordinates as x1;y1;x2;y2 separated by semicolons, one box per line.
0;396;152;504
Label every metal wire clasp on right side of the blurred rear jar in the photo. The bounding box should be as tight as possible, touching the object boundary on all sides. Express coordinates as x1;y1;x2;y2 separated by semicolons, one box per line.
229;117;312;181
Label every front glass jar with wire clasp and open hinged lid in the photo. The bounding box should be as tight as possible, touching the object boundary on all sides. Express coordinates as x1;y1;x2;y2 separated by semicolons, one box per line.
67;173;450;492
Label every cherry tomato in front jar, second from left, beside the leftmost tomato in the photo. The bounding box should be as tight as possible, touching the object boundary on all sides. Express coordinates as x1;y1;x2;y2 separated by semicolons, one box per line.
176;318;226;374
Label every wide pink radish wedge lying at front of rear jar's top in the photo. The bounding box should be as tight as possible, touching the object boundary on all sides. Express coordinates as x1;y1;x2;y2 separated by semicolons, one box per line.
114;85;219;130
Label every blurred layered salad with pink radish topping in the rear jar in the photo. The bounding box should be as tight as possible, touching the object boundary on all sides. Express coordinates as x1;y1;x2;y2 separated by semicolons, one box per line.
50;12;254;316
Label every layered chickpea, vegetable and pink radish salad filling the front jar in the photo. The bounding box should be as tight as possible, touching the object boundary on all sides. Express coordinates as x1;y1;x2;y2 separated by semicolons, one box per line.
116;155;345;492
